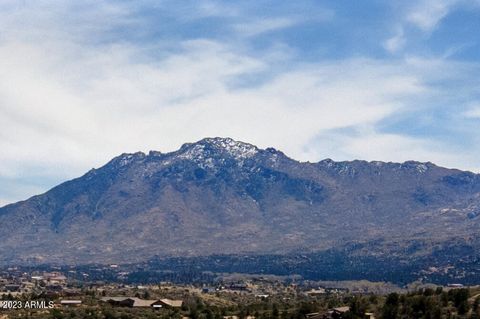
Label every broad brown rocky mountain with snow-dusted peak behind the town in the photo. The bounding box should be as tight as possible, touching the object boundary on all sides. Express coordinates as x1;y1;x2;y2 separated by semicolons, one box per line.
0;138;480;274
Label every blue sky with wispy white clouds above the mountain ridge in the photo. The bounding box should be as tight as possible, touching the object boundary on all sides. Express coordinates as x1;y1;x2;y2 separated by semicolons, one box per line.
0;0;480;205
